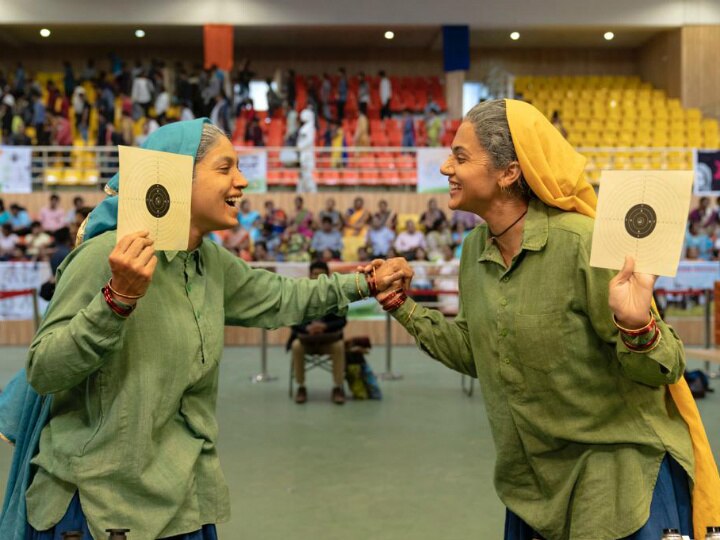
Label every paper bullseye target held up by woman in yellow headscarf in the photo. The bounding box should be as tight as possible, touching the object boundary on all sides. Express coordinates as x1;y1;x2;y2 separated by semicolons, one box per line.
590;171;693;276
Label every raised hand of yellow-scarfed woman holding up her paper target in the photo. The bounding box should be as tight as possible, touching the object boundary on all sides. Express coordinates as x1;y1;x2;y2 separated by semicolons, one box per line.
609;255;657;330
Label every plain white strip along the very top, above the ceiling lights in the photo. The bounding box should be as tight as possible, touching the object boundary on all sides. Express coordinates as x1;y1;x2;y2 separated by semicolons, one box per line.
0;0;720;28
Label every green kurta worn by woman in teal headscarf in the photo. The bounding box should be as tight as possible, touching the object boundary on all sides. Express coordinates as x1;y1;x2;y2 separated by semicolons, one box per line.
27;231;367;540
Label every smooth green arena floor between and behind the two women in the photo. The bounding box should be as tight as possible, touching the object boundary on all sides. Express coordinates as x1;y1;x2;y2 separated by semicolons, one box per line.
0;348;720;540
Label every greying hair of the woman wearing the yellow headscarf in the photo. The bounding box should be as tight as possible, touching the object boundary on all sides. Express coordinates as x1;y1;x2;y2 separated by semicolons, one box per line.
465;99;533;199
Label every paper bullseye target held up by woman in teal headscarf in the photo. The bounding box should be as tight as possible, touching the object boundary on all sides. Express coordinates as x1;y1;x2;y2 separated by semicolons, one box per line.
117;146;193;250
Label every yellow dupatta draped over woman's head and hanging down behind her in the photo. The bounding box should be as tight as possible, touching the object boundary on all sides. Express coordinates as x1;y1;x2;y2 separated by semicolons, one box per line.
505;99;720;539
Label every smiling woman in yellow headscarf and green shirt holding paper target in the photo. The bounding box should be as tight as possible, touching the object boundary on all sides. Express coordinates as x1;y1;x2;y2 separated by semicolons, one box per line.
366;100;720;540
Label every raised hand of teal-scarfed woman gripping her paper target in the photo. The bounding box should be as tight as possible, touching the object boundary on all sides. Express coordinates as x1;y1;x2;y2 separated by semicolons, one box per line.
108;231;157;305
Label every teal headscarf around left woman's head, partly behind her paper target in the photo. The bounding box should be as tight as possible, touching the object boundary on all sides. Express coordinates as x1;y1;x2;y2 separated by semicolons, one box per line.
79;118;210;240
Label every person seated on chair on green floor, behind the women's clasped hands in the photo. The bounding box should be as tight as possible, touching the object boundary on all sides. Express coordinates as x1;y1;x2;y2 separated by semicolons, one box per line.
287;261;347;405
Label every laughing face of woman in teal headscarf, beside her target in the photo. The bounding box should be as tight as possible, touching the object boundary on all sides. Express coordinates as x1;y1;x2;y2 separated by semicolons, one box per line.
191;137;248;234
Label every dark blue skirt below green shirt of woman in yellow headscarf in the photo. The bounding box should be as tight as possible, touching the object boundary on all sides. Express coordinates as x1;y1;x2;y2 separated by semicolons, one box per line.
505;454;692;540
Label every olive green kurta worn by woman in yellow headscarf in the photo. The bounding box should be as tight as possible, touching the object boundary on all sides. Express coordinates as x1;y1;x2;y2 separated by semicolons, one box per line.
395;200;693;540
